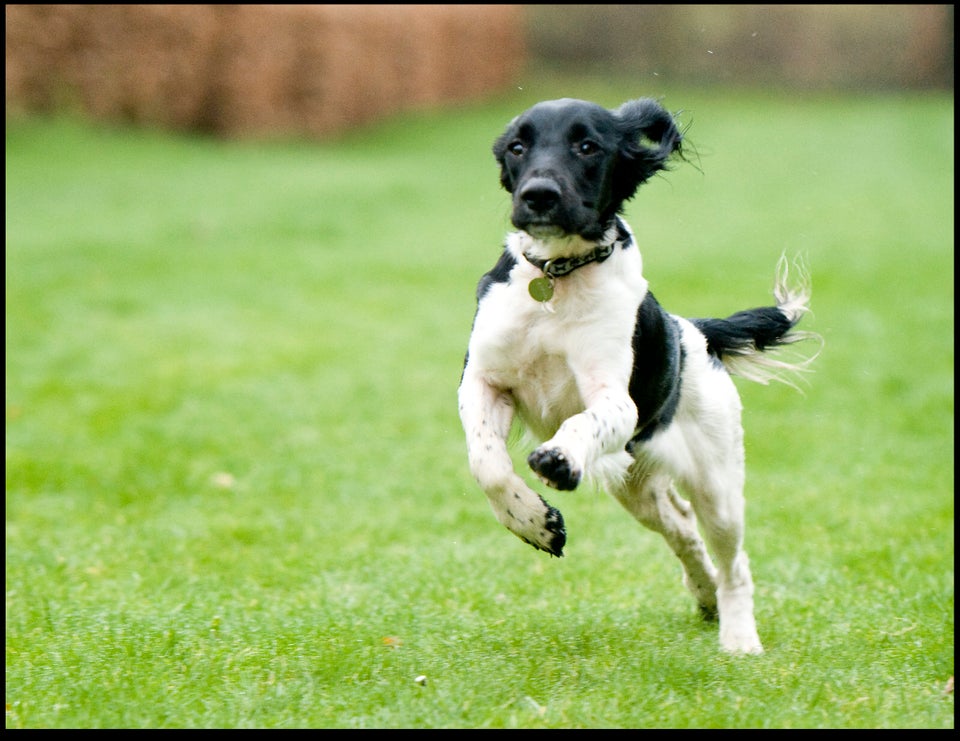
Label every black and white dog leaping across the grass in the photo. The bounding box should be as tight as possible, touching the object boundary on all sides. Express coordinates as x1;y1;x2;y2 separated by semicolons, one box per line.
459;94;809;653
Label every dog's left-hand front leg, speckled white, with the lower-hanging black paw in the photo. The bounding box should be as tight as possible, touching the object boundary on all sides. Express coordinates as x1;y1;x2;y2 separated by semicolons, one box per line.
459;369;567;556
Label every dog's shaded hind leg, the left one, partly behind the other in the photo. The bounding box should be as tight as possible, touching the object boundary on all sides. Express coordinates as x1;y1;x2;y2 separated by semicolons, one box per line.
612;474;717;618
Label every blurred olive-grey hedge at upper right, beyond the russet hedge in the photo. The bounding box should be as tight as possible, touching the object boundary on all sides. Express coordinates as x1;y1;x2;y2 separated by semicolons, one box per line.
524;5;954;90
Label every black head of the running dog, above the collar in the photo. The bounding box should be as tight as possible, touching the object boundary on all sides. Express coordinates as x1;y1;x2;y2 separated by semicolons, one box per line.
493;98;681;240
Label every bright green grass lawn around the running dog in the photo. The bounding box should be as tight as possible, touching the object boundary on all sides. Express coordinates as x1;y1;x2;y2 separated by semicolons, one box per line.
6;81;954;728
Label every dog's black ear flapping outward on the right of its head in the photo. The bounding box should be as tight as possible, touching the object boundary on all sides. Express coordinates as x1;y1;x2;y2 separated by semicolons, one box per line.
613;98;683;201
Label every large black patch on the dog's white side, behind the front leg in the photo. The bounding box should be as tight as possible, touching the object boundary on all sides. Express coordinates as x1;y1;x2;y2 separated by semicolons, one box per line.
627;291;683;453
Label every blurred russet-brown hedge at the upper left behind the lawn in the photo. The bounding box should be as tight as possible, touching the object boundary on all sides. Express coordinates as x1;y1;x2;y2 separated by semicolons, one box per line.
6;5;524;136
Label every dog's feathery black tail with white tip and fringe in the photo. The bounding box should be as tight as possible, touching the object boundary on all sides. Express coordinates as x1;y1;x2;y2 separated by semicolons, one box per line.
690;256;823;388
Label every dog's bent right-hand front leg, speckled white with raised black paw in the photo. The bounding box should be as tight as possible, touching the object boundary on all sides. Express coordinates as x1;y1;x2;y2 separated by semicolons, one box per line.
527;382;637;491
